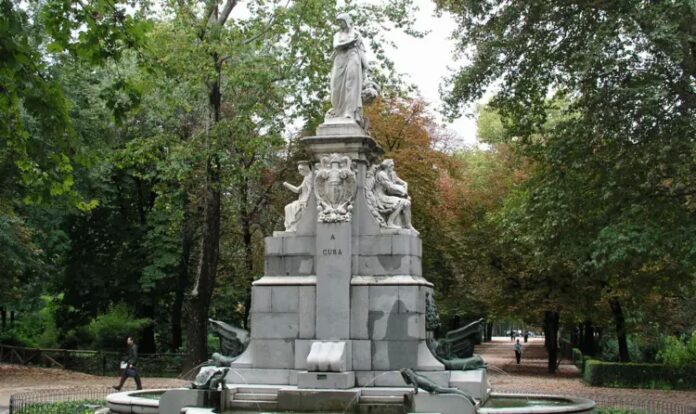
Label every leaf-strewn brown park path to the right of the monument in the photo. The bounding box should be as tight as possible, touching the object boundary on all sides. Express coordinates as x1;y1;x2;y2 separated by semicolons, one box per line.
474;337;696;413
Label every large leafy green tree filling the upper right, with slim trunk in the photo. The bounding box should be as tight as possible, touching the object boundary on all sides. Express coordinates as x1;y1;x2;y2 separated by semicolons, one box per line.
438;0;696;361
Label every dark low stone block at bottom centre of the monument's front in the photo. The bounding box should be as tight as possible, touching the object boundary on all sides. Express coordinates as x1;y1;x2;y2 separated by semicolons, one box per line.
278;389;360;413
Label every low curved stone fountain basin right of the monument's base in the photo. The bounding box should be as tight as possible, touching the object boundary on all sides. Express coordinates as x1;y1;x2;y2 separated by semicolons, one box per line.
476;393;595;414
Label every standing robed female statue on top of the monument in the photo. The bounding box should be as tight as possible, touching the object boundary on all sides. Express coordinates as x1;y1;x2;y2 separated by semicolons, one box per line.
326;13;367;125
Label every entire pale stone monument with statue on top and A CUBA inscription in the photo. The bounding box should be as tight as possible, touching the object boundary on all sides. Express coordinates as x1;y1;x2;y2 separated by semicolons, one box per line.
219;14;486;409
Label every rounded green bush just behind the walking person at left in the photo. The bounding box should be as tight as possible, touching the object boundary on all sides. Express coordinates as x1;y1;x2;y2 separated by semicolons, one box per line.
89;303;152;350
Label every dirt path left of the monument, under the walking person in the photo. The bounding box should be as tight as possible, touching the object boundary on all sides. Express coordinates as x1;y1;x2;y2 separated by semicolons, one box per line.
0;364;190;414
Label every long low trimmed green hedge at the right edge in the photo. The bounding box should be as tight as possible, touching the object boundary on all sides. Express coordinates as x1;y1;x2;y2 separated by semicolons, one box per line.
583;358;696;390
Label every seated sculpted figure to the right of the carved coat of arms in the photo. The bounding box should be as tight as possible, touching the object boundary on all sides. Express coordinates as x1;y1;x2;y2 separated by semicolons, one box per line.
374;159;415;230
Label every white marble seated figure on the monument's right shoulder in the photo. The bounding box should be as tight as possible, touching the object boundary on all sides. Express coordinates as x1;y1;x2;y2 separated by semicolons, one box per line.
365;159;415;231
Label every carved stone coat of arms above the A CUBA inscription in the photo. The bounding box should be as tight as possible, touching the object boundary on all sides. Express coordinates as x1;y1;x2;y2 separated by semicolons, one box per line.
314;154;356;223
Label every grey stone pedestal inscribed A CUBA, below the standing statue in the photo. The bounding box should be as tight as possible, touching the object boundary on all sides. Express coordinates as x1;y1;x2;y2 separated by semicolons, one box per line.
228;119;464;394
